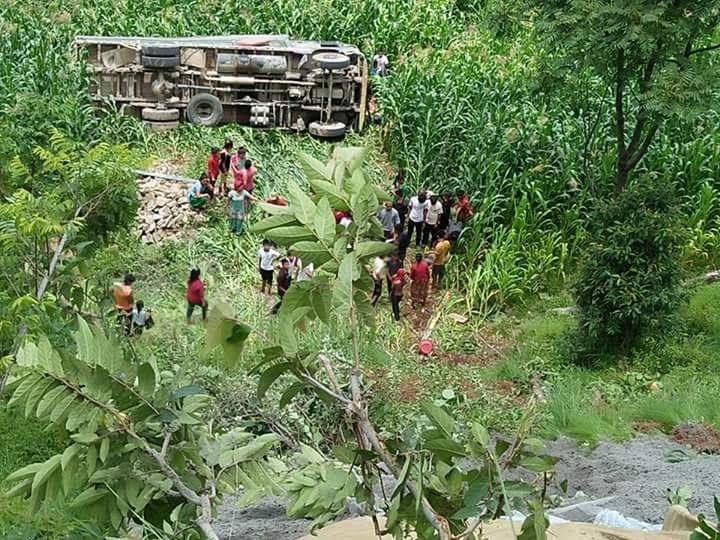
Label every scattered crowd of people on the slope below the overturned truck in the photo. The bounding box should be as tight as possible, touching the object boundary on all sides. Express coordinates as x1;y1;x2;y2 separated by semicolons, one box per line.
120;151;473;335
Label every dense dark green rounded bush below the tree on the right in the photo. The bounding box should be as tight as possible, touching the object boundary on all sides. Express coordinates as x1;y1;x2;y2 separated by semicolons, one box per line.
574;178;683;361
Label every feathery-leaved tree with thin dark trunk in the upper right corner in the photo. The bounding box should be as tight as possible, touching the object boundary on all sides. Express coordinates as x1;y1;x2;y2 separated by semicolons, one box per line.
527;0;720;191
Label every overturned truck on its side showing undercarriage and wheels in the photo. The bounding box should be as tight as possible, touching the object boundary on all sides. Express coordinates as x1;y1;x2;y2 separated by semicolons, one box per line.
75;35;368;138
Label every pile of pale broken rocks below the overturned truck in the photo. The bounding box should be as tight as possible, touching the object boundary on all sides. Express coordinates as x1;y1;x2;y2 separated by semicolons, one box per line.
137;177;206;244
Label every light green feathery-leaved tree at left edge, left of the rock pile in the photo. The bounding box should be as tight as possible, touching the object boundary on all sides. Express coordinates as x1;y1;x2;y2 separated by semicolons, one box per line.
0;130;137;354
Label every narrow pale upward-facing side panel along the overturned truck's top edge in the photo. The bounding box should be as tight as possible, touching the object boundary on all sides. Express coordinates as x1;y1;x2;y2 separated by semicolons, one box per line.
75;34;362;55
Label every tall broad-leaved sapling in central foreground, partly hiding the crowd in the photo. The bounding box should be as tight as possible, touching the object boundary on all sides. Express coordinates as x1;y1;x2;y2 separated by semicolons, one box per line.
245;148;554;540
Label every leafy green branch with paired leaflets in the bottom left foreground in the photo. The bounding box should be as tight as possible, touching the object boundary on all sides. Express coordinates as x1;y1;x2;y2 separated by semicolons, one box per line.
6;319;282;539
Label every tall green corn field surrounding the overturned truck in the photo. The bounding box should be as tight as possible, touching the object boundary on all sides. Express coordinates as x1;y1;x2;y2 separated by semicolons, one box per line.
0;0;720;315
